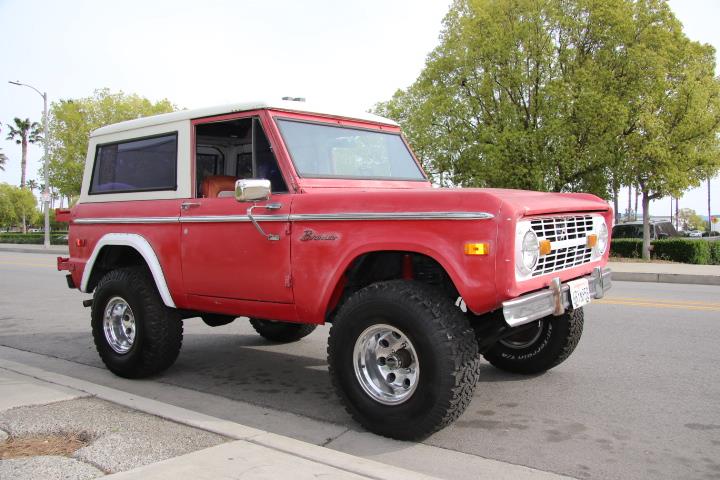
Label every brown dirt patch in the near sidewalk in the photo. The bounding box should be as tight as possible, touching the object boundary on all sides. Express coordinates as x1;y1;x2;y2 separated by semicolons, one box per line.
0;432;92;460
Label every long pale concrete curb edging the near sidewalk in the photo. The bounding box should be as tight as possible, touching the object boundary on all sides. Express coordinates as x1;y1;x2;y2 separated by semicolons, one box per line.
0;360;438;480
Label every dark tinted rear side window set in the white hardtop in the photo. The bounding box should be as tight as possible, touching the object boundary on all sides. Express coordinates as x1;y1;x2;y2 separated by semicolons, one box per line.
89;132;177;195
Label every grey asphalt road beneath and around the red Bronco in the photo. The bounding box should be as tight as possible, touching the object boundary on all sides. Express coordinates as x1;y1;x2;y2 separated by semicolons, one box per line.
0;252;720;480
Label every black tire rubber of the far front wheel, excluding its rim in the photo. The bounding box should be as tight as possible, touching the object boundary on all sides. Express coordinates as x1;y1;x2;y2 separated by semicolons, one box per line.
484;308;585;375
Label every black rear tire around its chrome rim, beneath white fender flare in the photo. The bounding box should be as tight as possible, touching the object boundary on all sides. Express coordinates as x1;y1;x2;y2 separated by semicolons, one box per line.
91;267;183;378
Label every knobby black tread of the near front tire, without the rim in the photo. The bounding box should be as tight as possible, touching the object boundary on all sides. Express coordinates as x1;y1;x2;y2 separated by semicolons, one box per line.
327;280;480;440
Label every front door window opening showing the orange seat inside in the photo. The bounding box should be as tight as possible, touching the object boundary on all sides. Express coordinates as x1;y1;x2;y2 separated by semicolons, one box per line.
195;117;288;198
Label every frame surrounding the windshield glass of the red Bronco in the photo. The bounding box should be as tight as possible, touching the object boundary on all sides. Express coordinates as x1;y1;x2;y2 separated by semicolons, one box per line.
272;116;429;184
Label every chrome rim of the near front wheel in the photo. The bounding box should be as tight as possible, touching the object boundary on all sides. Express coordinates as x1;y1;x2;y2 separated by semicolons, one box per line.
353;324;420;405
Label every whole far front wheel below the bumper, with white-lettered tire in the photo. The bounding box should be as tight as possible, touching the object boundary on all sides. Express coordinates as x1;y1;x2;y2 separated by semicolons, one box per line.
484;308;584;374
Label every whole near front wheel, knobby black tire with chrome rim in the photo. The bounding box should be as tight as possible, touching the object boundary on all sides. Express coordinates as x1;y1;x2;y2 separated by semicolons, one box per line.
328;281;480;440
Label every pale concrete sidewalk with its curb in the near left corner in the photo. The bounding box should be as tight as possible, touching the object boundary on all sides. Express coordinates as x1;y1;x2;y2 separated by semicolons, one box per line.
0;360;438;480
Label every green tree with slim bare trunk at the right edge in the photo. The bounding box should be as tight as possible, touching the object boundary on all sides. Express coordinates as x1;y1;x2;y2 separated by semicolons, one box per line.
623;0;720;258
